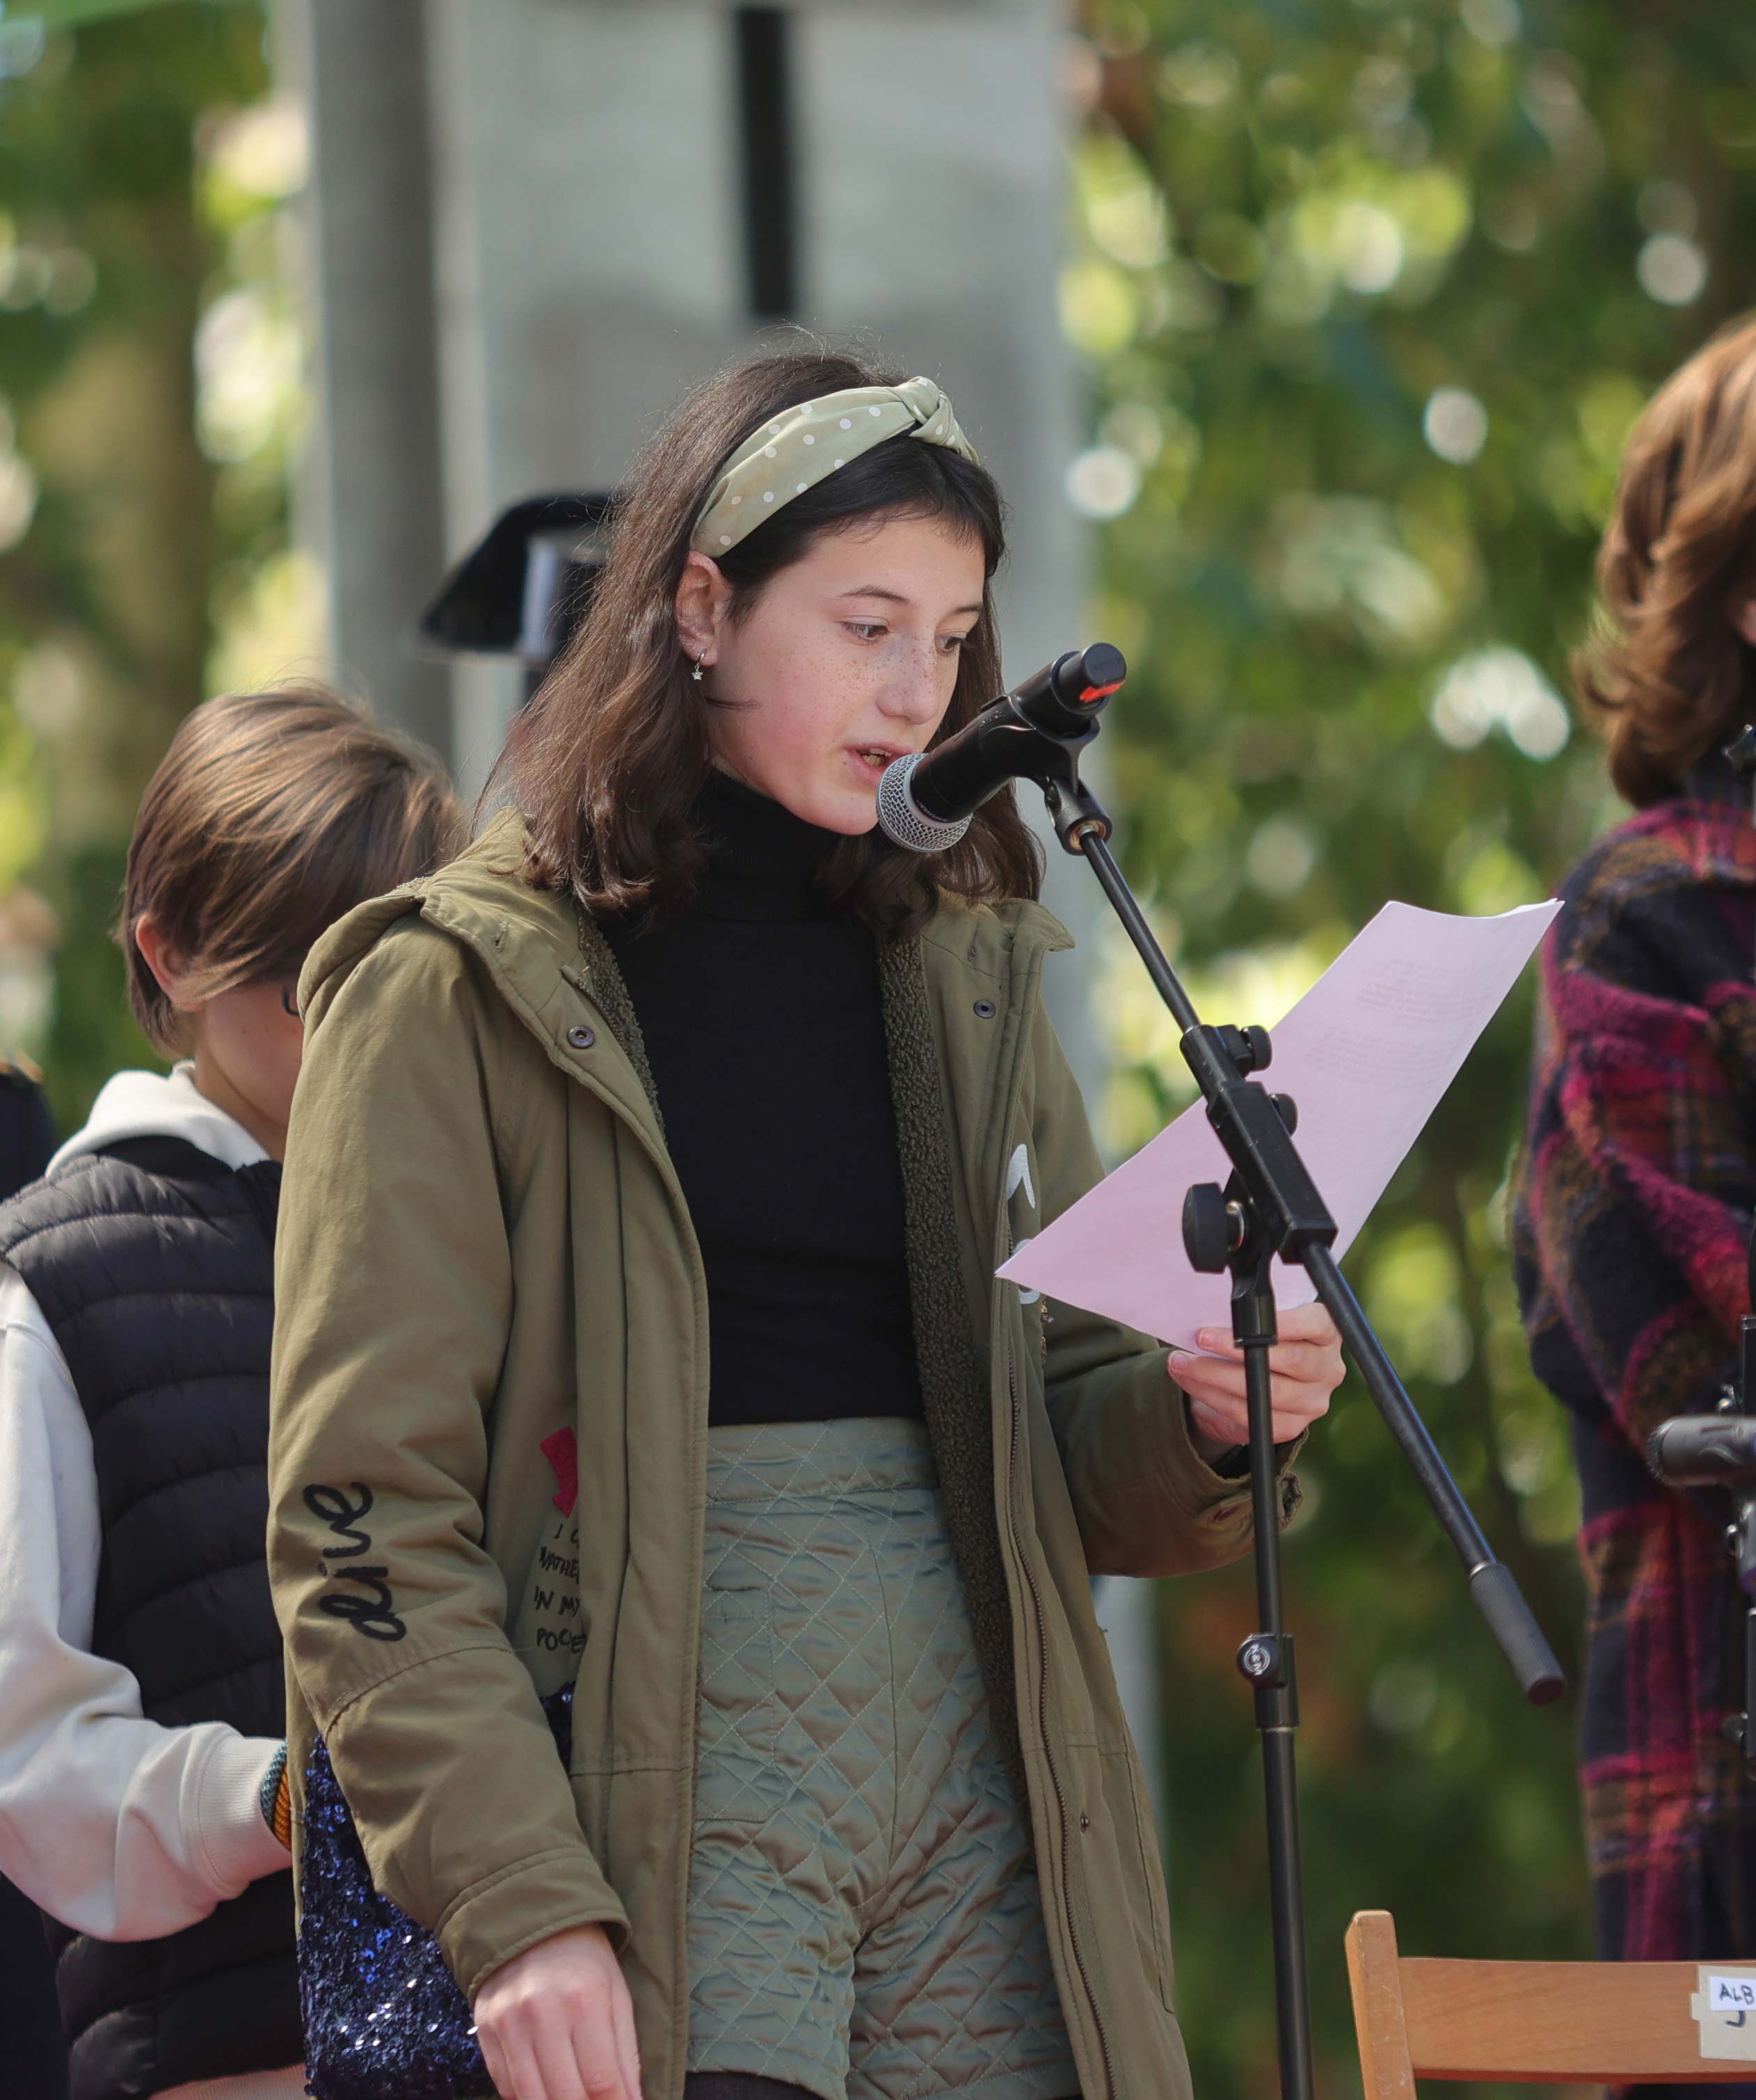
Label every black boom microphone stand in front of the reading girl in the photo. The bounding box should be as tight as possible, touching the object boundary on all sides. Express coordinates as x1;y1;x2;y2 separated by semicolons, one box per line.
1016;721;1571;2100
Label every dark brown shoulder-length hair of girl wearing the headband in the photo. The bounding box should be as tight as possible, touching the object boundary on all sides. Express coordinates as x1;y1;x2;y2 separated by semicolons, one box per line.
493;351;1041;936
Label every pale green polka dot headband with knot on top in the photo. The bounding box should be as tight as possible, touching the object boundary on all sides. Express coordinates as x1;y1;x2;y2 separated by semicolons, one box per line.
689;378;975;554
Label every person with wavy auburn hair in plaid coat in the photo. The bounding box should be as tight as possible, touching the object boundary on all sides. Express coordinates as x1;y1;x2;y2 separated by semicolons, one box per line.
1517;323;1756;1999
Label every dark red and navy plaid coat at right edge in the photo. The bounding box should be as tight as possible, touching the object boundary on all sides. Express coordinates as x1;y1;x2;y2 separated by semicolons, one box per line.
1515;777;1756;1962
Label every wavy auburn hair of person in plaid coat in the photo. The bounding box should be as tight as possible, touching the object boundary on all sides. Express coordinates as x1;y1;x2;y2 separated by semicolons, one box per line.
1573;321;1756;808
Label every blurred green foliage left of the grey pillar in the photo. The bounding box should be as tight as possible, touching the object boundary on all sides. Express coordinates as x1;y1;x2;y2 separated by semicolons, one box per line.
0;4;286;1130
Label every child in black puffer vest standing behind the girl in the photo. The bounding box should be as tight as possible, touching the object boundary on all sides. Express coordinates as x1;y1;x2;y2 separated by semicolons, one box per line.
0;684;462;2100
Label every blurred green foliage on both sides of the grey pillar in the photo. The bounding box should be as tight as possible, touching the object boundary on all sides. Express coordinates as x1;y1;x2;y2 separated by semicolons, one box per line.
0;0;1756;2100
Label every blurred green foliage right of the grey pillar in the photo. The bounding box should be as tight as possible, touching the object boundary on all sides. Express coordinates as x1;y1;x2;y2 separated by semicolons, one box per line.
1063;0;1756;2100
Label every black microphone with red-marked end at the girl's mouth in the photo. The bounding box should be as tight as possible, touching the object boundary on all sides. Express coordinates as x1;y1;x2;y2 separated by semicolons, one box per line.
878;643;1128;853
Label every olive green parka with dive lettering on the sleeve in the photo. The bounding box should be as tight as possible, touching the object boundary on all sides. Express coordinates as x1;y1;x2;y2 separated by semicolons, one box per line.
269;817;1296;2100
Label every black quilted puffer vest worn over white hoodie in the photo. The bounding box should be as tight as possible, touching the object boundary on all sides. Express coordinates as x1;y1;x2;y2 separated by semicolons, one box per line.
0;1138;303;2100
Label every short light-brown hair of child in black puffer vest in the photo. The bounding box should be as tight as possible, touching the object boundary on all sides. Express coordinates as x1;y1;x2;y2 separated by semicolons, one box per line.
118;682;464;1057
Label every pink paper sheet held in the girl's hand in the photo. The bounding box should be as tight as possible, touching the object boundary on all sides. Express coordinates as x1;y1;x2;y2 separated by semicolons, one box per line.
998;901;1561;1348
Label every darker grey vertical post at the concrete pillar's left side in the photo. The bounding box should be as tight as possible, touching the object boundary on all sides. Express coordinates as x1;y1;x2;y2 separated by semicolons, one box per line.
309;0;452;758
